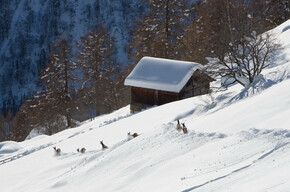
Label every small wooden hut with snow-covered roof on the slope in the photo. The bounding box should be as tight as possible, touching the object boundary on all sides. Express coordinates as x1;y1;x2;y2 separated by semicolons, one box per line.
125;57;213;113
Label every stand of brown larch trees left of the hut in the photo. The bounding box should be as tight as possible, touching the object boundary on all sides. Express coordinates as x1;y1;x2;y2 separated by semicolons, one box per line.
0;25;129;140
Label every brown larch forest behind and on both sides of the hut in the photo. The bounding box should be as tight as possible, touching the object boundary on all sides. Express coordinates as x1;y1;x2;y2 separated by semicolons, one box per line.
0;0;290;141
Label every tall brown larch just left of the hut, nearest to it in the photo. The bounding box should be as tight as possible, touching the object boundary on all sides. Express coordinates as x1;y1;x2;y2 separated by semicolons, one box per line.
77;24;115;117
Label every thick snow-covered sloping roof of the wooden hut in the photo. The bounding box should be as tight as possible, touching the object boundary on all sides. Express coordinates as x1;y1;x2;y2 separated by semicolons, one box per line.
124;57;203;93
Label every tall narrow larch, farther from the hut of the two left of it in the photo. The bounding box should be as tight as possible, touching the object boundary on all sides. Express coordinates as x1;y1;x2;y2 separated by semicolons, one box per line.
39;38;77;130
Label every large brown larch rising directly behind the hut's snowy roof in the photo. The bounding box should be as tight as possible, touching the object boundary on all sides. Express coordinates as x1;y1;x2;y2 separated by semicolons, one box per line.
128;0;194;61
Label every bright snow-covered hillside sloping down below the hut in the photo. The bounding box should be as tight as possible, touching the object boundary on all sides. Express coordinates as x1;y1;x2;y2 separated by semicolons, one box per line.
0;20;290;192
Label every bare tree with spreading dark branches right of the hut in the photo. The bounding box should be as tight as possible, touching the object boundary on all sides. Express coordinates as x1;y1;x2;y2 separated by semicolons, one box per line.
206;31;279;86
